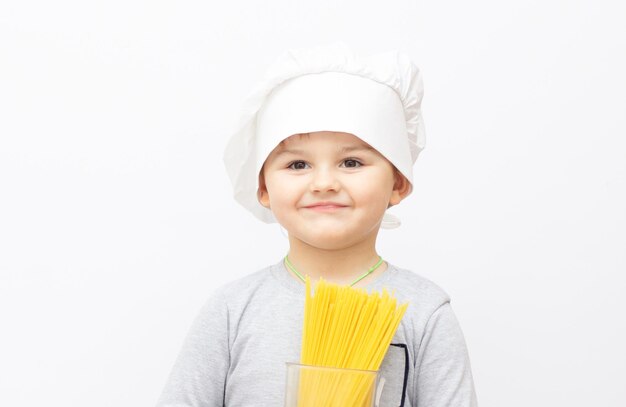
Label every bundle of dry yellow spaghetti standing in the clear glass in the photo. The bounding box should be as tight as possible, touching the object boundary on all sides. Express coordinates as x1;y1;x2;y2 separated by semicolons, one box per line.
298;277;408;407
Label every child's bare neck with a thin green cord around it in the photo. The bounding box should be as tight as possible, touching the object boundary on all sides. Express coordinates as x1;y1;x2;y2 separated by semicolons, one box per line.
289;234;387;287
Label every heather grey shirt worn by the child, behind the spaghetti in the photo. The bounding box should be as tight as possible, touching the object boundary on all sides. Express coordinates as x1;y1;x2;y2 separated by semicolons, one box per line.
157;260;477;407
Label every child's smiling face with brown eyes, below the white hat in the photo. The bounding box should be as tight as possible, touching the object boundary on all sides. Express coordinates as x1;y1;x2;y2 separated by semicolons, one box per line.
258;131;410;249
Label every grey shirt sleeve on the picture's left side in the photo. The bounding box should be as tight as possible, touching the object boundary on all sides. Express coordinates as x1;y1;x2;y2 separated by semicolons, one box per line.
157;293;229;407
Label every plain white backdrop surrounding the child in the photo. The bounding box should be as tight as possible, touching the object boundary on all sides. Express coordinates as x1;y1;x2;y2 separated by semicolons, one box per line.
0;0;626;407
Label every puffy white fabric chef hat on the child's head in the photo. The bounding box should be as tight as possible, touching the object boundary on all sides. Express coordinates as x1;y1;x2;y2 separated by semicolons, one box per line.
224;42;425;229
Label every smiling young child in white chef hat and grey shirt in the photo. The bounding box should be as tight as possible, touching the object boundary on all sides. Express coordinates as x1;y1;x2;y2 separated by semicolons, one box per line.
158;44;477;407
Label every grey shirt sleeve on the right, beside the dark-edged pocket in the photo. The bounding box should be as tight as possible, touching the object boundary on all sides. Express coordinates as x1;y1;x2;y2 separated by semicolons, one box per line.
413;302;478;407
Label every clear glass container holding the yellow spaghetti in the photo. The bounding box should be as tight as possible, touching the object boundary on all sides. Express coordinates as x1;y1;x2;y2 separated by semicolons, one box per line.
285;363;382;407
